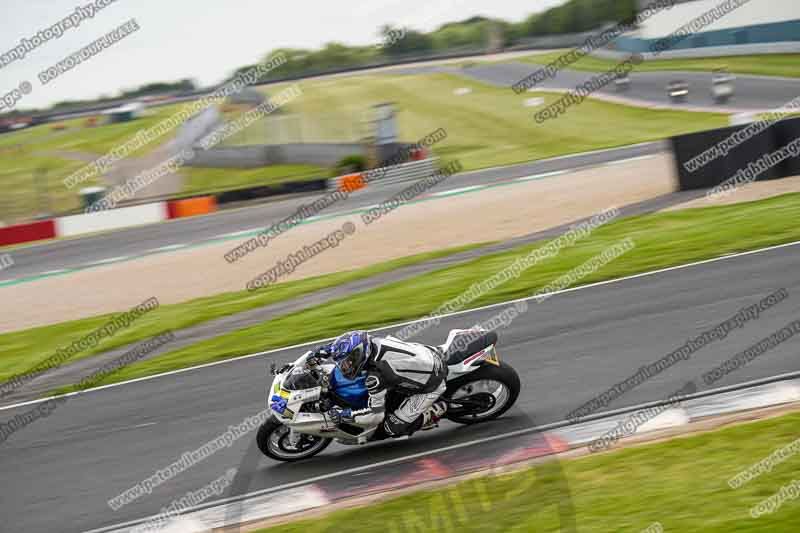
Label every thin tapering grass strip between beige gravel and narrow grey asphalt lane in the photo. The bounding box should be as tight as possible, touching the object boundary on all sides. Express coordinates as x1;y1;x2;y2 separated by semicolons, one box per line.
0;243;485;381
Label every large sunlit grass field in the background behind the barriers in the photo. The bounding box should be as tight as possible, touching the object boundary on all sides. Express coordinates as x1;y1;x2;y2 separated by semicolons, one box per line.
267;74;728;170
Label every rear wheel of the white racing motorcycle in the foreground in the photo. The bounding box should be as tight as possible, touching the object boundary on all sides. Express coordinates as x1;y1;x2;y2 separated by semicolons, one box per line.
444;362;521;424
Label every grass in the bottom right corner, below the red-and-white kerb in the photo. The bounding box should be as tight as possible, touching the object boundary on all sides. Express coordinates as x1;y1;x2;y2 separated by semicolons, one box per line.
253;413;800;533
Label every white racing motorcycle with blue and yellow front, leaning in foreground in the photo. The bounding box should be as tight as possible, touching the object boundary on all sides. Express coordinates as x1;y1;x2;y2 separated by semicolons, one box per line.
256;329;520;462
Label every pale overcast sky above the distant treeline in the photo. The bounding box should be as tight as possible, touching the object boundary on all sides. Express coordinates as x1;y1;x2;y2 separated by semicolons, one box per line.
0;0;565;109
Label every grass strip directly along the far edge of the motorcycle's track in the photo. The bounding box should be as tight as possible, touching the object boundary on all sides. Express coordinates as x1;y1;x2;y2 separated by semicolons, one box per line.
94;193;800;382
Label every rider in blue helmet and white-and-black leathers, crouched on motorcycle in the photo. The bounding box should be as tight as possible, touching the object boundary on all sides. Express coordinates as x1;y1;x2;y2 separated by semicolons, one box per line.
314;331;447;439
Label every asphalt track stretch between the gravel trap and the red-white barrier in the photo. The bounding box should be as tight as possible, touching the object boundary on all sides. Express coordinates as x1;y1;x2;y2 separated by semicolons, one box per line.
0;142;666;282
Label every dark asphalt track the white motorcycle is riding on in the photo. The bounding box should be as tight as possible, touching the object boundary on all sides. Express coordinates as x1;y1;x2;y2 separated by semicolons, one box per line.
0;245;800;532
